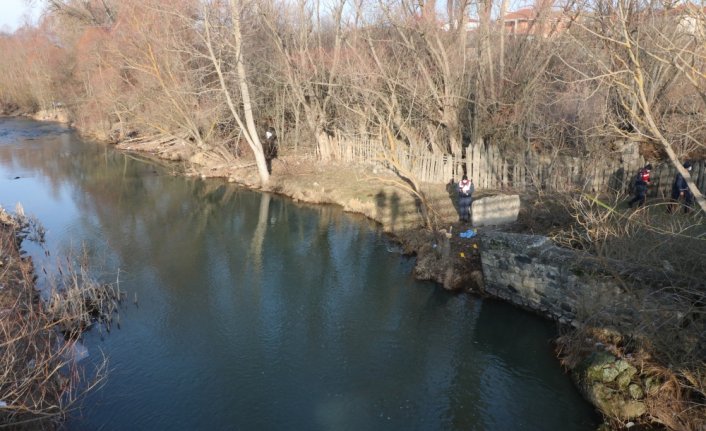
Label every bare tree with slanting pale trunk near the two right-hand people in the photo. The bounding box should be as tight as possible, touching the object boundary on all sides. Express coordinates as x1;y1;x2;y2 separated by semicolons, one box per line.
568;0;706;211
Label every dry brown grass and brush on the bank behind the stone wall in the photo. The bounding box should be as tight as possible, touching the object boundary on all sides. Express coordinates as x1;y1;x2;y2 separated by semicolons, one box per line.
555;196;706;430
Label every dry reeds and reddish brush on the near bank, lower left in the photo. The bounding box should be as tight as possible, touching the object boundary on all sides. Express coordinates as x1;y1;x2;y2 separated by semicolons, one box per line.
0;208;120;430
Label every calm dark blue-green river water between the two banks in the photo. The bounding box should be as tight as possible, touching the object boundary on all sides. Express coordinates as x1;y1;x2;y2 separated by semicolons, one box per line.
0;118;598;430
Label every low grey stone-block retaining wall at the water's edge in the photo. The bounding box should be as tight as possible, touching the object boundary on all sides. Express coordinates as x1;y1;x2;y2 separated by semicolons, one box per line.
480;232;631;324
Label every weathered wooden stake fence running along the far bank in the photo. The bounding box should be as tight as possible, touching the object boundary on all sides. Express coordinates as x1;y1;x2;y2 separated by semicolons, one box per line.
334;139;706;199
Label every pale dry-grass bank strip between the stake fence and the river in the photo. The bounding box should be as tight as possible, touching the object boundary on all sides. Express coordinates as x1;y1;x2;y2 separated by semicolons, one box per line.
117;141;494;293
